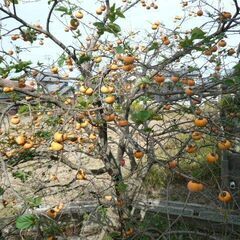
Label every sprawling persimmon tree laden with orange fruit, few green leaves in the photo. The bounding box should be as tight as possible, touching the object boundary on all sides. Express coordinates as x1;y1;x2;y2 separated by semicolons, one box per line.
0;0;240;238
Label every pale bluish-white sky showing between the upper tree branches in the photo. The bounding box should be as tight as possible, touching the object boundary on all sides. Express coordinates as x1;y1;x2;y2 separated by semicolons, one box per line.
0;0;238;73
